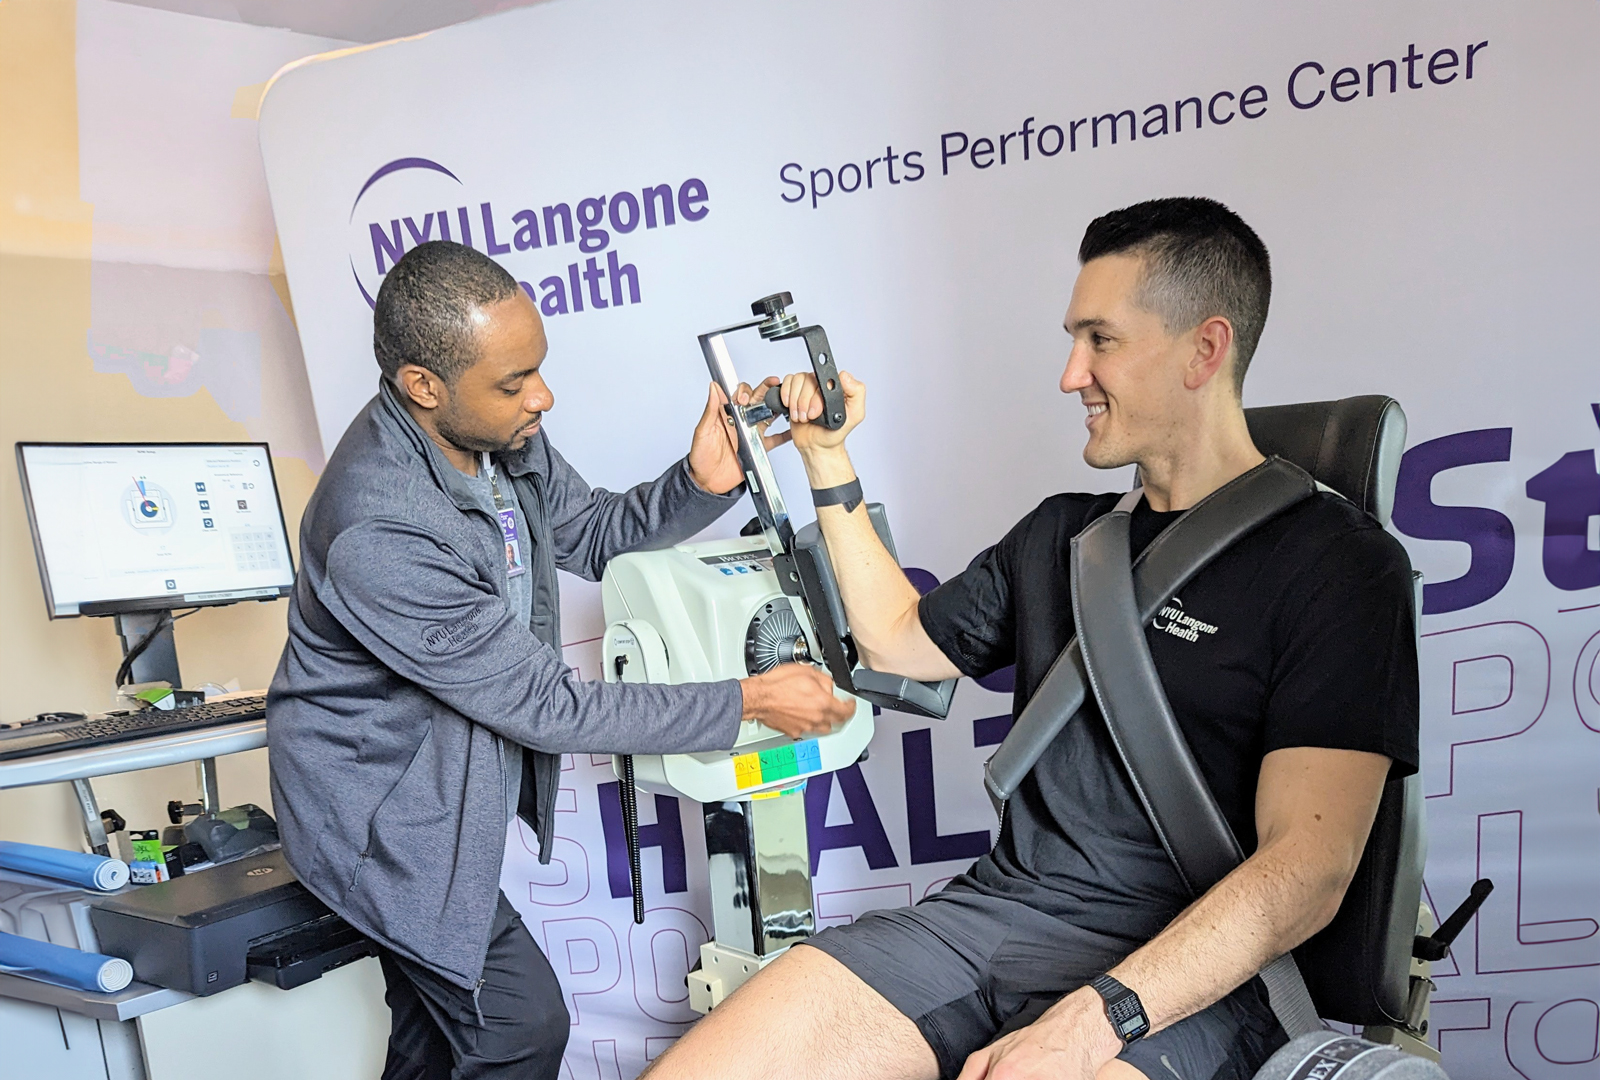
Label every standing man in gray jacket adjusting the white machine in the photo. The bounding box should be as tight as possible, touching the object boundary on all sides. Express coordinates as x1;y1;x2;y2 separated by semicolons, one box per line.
267;242;853;1080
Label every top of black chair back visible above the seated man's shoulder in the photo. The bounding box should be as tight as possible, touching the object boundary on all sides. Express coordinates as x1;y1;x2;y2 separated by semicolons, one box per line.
1245;394;1406;525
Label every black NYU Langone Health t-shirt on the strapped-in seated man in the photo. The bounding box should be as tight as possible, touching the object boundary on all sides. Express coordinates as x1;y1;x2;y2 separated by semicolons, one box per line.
920;493;1418;942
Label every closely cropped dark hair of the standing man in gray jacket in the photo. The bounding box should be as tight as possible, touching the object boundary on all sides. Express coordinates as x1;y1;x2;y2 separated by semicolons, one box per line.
373;240;518;386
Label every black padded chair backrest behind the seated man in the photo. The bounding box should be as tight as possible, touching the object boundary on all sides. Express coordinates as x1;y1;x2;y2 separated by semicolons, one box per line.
1245;395;1427;1024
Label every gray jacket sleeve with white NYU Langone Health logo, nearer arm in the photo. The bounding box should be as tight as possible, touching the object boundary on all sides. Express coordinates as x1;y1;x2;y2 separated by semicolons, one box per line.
318;520;742;754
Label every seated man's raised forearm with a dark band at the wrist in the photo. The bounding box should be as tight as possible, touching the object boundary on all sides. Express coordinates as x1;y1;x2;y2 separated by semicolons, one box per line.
802;446;949;678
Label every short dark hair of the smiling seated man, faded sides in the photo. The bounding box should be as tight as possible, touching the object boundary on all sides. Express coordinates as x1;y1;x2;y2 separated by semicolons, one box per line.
1078;198;1272;390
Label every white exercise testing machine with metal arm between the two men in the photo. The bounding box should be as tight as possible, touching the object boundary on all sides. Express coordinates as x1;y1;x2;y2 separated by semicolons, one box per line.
602;293;955;1013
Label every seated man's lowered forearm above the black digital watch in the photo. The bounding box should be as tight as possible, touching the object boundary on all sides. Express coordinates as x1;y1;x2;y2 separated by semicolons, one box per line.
1110;838;1349;1030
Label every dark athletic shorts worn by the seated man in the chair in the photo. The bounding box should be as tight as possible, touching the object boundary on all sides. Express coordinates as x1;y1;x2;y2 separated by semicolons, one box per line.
805;886;1288;1080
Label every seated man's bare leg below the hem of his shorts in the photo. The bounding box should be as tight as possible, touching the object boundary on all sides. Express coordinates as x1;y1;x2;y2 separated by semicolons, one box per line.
645;946;939;1080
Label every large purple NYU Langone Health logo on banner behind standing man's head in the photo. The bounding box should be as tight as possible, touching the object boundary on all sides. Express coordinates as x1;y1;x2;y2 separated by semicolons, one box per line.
349;157;710;318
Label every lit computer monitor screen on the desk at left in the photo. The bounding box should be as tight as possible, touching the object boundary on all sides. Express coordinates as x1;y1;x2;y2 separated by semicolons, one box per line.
16;443;294;618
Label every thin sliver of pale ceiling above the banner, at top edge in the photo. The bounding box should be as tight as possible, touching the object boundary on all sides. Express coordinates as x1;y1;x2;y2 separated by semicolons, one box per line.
108;0;539;43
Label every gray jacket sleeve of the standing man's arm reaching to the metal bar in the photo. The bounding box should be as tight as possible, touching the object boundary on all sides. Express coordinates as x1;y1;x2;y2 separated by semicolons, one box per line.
546;443;744;581
